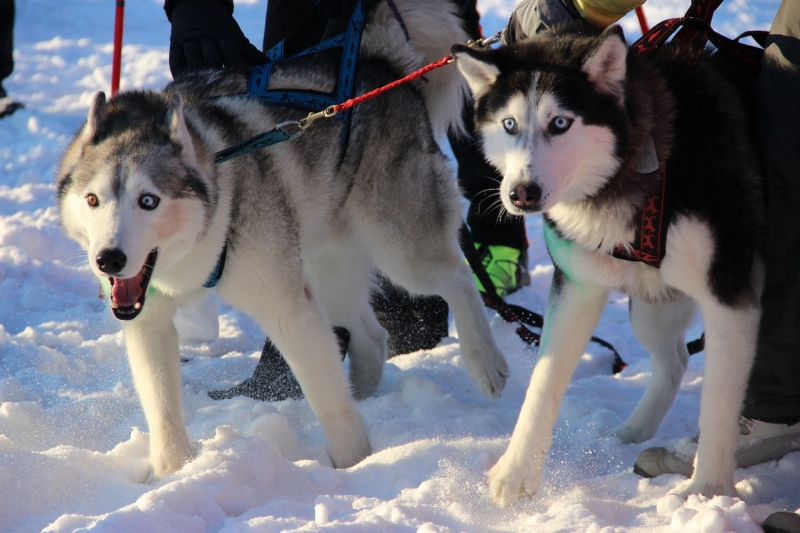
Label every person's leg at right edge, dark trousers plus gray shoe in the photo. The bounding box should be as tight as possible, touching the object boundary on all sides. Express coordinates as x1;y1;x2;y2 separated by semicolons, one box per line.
634;0;800;477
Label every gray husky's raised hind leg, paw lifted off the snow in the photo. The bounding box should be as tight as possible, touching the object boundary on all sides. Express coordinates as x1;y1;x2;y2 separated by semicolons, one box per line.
356;150;508;398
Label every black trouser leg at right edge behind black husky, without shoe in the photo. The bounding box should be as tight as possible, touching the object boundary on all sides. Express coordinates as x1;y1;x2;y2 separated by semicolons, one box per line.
743;0;800;423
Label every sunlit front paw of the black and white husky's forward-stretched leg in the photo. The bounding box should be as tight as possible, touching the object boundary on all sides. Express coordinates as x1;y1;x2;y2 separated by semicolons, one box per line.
489;450;544;509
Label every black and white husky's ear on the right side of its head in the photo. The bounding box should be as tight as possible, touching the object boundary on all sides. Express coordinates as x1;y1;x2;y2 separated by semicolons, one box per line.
582;24;628;102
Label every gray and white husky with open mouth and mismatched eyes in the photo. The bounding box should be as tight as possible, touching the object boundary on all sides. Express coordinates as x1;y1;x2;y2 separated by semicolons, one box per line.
57;0;508;477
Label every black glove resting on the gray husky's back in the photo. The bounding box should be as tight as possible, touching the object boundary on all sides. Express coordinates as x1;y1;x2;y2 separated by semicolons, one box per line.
169;0;268;78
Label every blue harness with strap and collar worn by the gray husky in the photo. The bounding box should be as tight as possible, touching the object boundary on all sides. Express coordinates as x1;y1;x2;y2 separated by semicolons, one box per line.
203;0;365;289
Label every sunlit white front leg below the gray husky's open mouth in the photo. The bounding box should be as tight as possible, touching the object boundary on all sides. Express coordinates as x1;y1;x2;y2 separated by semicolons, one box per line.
123;292;192;478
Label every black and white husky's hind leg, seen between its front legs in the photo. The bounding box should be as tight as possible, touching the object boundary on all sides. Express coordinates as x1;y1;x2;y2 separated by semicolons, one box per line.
610;297;696;442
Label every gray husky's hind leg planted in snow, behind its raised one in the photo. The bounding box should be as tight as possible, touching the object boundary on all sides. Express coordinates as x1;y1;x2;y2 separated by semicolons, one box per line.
305;241;389;399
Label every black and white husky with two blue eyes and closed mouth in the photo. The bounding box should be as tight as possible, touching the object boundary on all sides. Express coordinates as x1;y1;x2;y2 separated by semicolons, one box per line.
453;25;765;506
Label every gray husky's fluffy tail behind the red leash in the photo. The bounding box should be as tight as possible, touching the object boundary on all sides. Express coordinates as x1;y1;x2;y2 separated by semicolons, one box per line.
361;0;469;139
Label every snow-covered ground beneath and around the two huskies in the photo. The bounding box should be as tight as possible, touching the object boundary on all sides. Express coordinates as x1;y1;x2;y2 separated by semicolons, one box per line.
0;0;800;533
